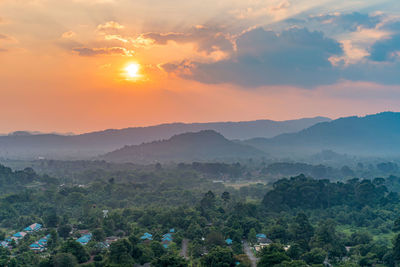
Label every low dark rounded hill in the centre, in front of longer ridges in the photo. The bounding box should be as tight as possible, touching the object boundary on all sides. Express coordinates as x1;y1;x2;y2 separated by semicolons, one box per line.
100;130;265;163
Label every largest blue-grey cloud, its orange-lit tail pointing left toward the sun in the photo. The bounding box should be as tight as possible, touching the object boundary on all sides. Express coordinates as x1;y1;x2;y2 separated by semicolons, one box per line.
163;28;343;87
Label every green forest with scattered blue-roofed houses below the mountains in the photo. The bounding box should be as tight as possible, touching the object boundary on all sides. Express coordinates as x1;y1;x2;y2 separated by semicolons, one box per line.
0;161;400;267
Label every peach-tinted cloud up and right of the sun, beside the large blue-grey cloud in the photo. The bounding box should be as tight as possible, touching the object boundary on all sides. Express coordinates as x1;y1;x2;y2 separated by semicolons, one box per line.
143;25;233;53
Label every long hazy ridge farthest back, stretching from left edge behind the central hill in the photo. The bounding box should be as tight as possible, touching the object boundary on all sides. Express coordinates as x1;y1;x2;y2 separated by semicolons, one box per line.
0;117;330;159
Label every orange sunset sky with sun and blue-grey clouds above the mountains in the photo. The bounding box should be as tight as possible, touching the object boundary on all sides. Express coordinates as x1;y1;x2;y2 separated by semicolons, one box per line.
0;0;400;133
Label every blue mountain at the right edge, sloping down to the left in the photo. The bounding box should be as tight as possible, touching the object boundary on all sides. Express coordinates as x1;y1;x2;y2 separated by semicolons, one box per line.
243;112;400;156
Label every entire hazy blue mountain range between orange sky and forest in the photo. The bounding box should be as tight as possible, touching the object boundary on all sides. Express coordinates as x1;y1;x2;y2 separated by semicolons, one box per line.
0;112;400;163
